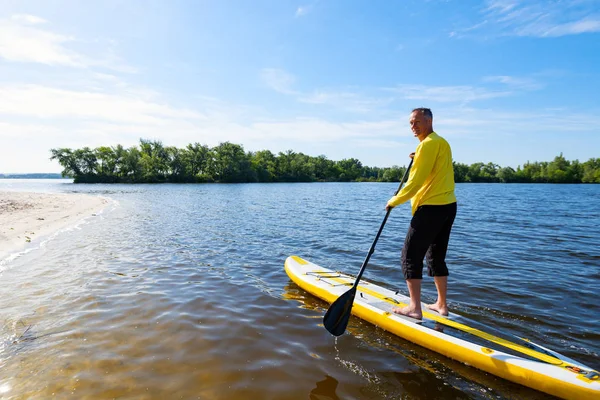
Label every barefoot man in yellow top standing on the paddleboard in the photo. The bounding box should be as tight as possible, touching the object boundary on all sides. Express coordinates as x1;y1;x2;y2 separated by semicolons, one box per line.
386;108;456;319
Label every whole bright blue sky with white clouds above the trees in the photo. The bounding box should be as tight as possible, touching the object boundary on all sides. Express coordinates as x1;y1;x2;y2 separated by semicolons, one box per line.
0;0;600;173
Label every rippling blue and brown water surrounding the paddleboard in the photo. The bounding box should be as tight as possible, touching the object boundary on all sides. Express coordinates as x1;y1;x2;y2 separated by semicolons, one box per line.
0;180;600;400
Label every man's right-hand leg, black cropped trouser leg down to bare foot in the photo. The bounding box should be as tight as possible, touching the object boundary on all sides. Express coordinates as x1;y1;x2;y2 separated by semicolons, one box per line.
426;203;456;315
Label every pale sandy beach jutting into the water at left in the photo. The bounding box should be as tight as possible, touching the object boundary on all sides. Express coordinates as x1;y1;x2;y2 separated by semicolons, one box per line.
0;191;108;260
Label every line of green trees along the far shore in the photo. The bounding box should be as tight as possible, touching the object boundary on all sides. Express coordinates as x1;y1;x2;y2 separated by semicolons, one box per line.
50;139;600;183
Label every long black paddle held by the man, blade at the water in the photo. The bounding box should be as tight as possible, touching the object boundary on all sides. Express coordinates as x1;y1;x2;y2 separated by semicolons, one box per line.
323;160;413;336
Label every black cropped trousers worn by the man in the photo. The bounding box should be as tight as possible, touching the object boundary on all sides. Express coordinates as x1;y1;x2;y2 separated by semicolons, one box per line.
402;203;456;279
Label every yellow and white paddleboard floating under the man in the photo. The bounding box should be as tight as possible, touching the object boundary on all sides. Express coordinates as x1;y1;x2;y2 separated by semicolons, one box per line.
285;256;600;400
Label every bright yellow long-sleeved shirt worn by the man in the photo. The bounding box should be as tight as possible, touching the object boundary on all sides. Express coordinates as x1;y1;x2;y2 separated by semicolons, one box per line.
387;132;456;215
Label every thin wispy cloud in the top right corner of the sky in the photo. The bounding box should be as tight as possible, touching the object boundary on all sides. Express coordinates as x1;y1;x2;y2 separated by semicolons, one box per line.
450;0;600;37
